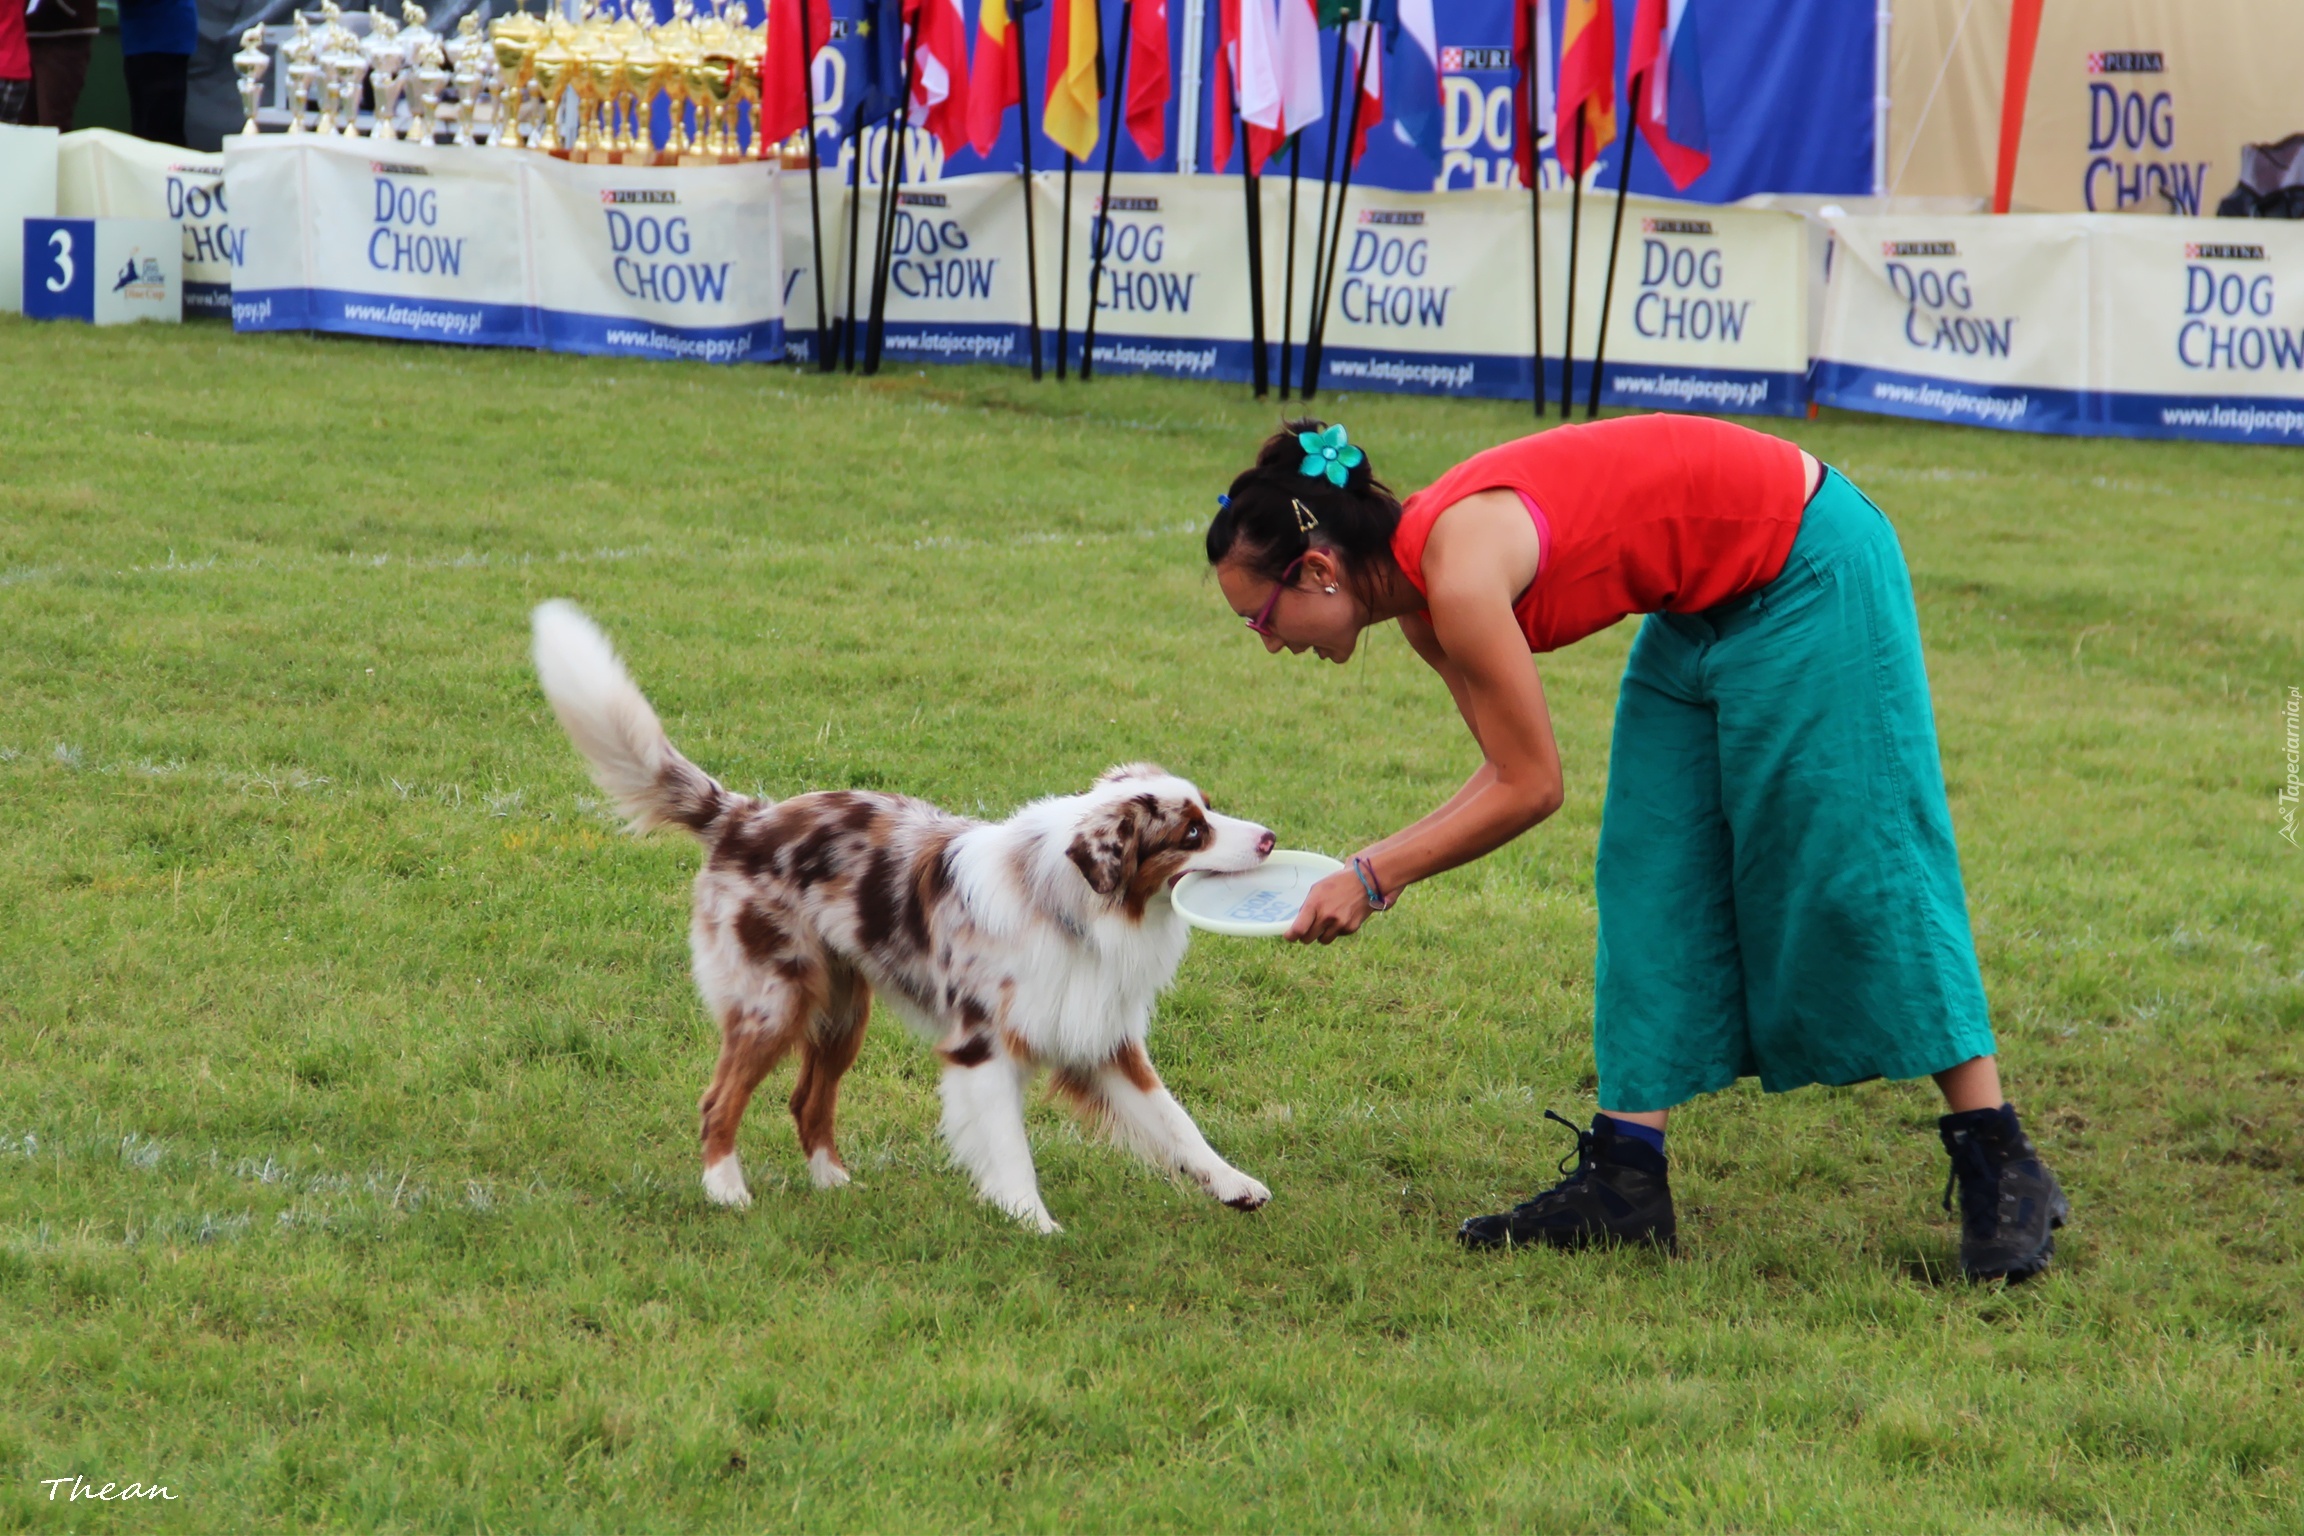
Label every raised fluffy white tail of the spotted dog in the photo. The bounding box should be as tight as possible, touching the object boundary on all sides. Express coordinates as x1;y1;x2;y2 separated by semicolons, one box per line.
535;599;735;834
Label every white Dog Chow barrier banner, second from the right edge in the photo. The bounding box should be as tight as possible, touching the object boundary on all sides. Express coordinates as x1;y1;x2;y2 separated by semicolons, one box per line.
1813;216;2087;433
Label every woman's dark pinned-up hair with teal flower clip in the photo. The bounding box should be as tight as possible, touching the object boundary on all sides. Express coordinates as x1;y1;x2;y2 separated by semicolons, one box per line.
1207;419;1401;587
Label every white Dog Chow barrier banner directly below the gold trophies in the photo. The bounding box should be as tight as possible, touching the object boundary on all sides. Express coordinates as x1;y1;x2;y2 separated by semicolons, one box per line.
523;154;783;362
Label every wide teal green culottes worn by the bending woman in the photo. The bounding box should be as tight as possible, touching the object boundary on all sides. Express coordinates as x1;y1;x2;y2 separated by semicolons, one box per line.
1592;470;1993;1110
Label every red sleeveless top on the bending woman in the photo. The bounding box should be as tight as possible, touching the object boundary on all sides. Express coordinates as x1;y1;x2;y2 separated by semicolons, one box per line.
1392;415;1806;652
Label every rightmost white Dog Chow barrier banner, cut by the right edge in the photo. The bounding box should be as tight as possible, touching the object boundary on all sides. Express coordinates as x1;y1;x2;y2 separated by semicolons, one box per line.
2087;219;2304;444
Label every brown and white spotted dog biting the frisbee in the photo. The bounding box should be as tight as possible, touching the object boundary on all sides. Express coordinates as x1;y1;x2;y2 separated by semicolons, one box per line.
535;601;1272;1232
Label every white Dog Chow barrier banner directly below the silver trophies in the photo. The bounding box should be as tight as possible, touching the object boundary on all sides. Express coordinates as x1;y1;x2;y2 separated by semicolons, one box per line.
223;134;544;345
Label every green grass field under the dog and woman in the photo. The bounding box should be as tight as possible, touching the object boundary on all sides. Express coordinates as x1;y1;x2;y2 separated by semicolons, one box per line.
0;322;2304;1531
